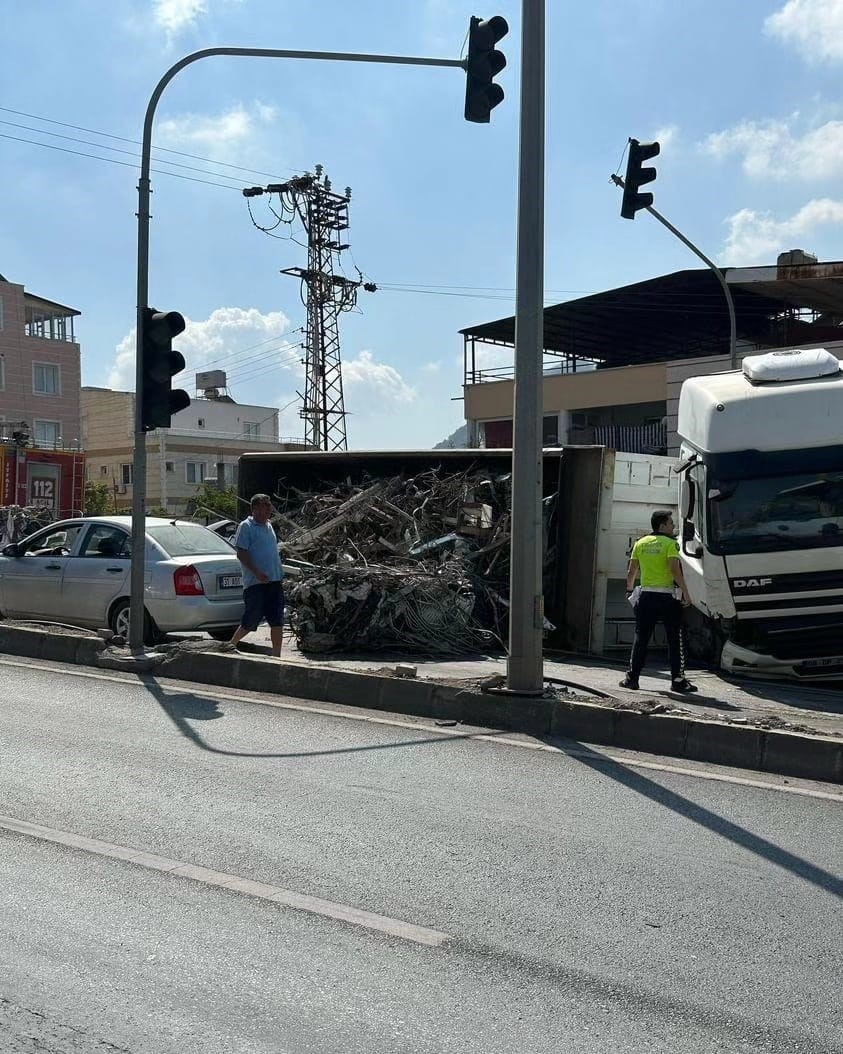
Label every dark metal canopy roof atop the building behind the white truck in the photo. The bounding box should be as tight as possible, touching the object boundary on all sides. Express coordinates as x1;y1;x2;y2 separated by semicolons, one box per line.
460;262;843;366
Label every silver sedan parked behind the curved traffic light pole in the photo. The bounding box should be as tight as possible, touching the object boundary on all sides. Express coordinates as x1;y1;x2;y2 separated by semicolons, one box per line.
0;516;243;642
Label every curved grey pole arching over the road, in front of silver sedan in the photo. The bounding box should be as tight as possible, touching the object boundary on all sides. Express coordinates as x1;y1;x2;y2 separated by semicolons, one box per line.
129;51;463;652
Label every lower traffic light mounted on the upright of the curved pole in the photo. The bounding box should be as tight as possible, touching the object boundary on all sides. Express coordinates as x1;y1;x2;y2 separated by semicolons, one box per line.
140;308;191;432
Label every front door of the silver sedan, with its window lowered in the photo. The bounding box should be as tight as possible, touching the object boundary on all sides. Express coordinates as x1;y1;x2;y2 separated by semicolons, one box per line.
0;521;84;623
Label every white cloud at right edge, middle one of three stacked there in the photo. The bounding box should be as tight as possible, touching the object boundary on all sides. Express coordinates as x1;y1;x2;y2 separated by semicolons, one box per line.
701;114;843;180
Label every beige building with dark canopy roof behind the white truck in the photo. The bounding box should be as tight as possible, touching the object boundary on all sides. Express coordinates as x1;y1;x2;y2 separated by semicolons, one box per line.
462;250;843;454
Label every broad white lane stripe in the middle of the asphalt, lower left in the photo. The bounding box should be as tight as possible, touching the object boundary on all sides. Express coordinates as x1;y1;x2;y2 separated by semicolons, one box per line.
0;816;452;948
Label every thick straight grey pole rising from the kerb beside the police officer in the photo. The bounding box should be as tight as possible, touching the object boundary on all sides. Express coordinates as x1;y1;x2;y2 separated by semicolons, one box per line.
507;0;545;696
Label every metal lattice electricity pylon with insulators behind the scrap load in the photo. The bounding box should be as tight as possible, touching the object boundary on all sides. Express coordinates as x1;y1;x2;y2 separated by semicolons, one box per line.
243;164;377;450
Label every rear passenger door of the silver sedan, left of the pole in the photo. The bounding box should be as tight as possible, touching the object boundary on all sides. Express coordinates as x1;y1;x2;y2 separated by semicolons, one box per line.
61;523;131;628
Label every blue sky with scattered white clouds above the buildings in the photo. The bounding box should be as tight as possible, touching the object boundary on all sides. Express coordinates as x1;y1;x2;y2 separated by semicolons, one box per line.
0;0;843;448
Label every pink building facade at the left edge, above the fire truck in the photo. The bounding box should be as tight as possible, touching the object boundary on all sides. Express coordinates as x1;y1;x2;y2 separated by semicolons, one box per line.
0;275;82;449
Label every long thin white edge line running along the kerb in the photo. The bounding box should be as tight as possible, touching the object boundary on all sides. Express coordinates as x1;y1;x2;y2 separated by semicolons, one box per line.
0;659;843;804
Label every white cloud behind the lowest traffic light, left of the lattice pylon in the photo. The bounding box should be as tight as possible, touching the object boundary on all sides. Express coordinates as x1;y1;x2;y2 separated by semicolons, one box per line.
106;308;290;391
